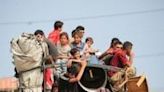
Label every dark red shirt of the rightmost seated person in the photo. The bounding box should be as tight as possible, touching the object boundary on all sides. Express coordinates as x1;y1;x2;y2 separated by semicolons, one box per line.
108;50;130;76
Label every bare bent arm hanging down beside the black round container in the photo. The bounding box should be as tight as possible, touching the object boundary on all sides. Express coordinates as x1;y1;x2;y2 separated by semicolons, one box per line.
69;61;87;83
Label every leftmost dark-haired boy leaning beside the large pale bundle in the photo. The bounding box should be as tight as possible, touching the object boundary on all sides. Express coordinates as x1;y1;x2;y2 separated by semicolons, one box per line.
34;30;58;92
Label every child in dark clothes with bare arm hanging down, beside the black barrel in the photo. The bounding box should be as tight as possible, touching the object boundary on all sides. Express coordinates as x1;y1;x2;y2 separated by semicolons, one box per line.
59;48;87;92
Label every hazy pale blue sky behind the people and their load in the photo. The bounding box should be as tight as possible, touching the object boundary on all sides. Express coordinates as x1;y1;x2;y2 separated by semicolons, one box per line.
0;0;164;92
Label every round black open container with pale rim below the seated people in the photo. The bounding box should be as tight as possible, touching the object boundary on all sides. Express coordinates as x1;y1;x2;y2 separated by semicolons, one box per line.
78;66;107;92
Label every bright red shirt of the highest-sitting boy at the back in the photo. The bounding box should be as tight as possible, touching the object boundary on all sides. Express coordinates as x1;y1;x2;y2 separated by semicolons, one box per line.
48;30;60;45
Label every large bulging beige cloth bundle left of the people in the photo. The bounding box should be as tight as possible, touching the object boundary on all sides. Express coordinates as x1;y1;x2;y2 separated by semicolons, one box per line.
10;33;48;72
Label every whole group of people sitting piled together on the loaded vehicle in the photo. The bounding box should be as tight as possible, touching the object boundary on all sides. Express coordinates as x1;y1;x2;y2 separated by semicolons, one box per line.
11;21;134;92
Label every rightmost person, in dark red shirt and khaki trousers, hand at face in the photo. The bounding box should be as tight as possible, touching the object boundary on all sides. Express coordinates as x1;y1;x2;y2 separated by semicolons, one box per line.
108;41;135;89
